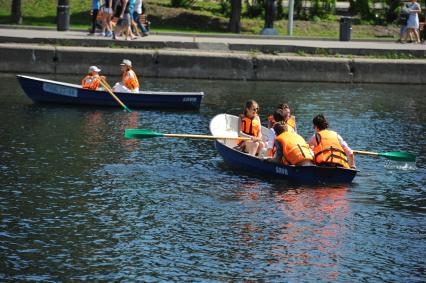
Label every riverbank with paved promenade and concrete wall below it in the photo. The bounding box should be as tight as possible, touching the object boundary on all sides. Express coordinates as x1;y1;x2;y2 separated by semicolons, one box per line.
0;28;426;84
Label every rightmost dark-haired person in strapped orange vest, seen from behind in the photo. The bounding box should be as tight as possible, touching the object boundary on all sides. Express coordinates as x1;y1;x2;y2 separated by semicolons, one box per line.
309;114;356;168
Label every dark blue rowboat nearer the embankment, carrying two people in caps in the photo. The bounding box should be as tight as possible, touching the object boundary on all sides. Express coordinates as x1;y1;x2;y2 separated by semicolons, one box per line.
17;75;204;109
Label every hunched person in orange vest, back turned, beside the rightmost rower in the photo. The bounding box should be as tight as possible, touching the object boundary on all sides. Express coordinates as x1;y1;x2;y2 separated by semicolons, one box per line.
272;122;314;166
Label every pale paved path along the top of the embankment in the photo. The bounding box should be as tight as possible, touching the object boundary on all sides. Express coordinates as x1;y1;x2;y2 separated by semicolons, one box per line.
0;26;426;56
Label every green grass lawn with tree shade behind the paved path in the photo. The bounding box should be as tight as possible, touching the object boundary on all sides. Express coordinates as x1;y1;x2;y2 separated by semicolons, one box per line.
0;0;399;39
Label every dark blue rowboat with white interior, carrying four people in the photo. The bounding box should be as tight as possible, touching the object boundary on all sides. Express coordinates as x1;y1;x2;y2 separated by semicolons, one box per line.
210;114;358;184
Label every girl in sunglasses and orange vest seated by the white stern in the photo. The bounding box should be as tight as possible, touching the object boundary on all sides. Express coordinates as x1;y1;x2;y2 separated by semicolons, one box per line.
238;100;265;155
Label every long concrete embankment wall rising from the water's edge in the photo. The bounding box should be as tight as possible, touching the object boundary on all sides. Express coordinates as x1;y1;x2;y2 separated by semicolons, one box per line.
0;43;426;84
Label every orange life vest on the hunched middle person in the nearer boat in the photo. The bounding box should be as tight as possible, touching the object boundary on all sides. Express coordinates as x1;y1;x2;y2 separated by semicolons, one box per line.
275;131;314;165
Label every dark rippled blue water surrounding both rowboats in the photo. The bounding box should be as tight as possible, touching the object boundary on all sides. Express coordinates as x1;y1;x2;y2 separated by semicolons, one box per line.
0;76;426;282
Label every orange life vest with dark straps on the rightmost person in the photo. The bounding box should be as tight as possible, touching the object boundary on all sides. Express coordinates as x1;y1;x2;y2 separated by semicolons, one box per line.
314;130;350;168
